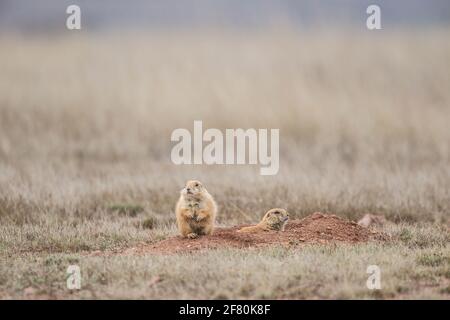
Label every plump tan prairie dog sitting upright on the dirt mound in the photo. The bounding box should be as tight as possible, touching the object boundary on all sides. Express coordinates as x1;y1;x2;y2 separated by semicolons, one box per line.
175;180;217;239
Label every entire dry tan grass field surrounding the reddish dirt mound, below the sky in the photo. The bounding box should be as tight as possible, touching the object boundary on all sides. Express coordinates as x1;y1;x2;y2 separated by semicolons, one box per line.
0;30;450;298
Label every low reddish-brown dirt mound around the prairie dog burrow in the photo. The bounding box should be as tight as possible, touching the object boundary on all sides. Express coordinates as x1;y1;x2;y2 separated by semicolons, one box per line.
122;212;385;254
